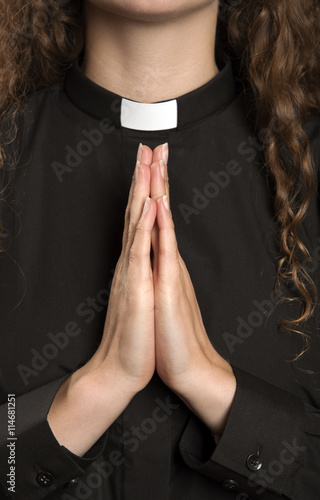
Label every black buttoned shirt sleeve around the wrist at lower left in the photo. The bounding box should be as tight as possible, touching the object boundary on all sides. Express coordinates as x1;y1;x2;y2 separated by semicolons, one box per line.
0;375;107;500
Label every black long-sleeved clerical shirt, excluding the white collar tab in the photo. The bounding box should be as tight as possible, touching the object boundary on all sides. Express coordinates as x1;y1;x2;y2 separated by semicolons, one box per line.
0;55;320;500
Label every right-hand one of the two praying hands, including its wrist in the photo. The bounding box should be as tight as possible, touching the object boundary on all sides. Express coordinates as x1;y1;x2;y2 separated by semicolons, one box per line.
149;144;236;434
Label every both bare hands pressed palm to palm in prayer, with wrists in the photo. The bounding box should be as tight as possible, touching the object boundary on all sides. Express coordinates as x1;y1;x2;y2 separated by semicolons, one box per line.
47;144;236;455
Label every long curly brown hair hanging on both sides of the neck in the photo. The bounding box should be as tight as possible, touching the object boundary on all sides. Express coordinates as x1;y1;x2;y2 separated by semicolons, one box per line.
0;0;320;360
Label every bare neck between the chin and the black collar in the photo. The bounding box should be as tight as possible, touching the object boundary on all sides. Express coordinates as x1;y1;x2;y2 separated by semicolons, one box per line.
82;2;219;102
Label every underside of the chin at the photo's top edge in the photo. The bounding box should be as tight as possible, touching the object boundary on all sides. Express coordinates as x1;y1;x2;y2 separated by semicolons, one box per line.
84;0;218;21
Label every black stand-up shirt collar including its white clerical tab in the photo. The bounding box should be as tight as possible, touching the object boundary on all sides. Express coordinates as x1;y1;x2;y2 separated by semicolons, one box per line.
64;54;235;130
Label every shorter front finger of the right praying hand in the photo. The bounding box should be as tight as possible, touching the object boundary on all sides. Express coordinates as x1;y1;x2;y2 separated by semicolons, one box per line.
155;195;180;284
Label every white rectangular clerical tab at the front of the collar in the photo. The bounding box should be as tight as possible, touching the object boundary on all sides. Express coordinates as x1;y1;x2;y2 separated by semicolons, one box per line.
120;97;178;130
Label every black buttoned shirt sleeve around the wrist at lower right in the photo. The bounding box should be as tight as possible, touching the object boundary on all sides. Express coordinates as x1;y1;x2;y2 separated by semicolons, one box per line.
180;367;320;500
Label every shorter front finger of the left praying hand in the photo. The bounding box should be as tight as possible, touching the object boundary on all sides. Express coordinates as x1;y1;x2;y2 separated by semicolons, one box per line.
128;197;157;283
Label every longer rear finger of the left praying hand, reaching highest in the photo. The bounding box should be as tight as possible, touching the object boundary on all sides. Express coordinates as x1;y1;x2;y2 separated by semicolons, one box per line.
122;145;152;252
